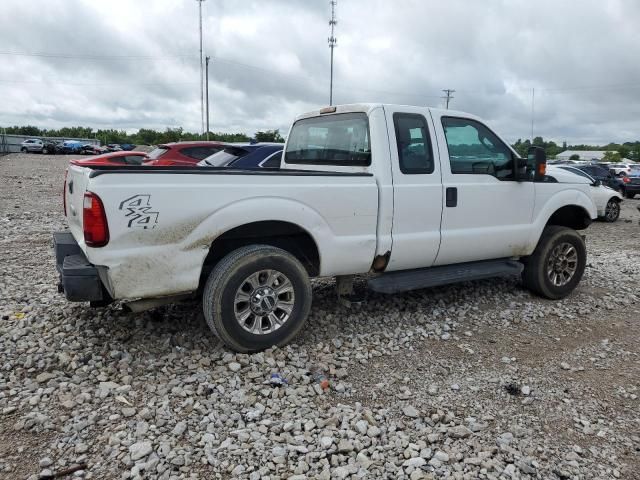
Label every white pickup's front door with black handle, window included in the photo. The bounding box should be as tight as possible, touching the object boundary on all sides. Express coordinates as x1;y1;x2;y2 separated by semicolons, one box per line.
431;110;534;265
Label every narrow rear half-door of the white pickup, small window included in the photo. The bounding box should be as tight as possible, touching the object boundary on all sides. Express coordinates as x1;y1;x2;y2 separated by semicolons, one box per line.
384;106;442;271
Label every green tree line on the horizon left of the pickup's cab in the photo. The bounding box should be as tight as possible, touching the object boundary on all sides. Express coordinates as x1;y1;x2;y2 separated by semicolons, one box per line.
0;125;284;145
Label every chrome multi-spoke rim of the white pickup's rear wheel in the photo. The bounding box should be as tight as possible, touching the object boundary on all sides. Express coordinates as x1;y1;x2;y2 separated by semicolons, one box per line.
233;270;295;335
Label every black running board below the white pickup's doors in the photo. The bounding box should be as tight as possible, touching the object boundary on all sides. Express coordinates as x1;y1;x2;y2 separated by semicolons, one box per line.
368;258;524;293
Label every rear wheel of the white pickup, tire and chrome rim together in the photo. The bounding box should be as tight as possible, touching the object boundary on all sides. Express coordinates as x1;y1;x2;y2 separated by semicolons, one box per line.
202;245;311;352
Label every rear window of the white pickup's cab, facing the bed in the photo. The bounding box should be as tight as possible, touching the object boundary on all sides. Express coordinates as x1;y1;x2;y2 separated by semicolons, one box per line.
284;113;371;166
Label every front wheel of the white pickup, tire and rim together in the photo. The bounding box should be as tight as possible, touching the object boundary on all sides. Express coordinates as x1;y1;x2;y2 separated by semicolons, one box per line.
522;225;587;300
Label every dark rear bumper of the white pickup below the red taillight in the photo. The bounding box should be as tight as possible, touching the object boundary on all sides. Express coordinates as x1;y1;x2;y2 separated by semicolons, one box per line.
53;232;112;304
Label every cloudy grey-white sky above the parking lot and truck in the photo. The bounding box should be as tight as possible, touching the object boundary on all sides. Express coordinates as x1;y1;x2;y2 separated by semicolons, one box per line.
0;0;640;143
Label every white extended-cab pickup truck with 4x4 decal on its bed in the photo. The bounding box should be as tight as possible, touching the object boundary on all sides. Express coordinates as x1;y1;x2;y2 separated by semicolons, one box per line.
54;104;597;352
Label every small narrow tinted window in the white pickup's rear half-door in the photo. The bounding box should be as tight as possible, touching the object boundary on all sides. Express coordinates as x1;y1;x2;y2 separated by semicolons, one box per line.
393;113;433;174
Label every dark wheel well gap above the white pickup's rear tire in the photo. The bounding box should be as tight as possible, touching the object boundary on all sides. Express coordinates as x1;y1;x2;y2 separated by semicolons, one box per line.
200;220;320;286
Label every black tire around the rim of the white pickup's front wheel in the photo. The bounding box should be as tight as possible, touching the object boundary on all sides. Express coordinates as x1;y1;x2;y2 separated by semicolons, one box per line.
522;225;587;300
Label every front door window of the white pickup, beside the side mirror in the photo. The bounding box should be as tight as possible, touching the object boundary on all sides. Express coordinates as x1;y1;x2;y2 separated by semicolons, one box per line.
442;117;514;180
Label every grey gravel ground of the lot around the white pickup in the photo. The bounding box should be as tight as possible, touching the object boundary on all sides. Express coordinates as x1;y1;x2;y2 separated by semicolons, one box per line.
0;154;640;480
